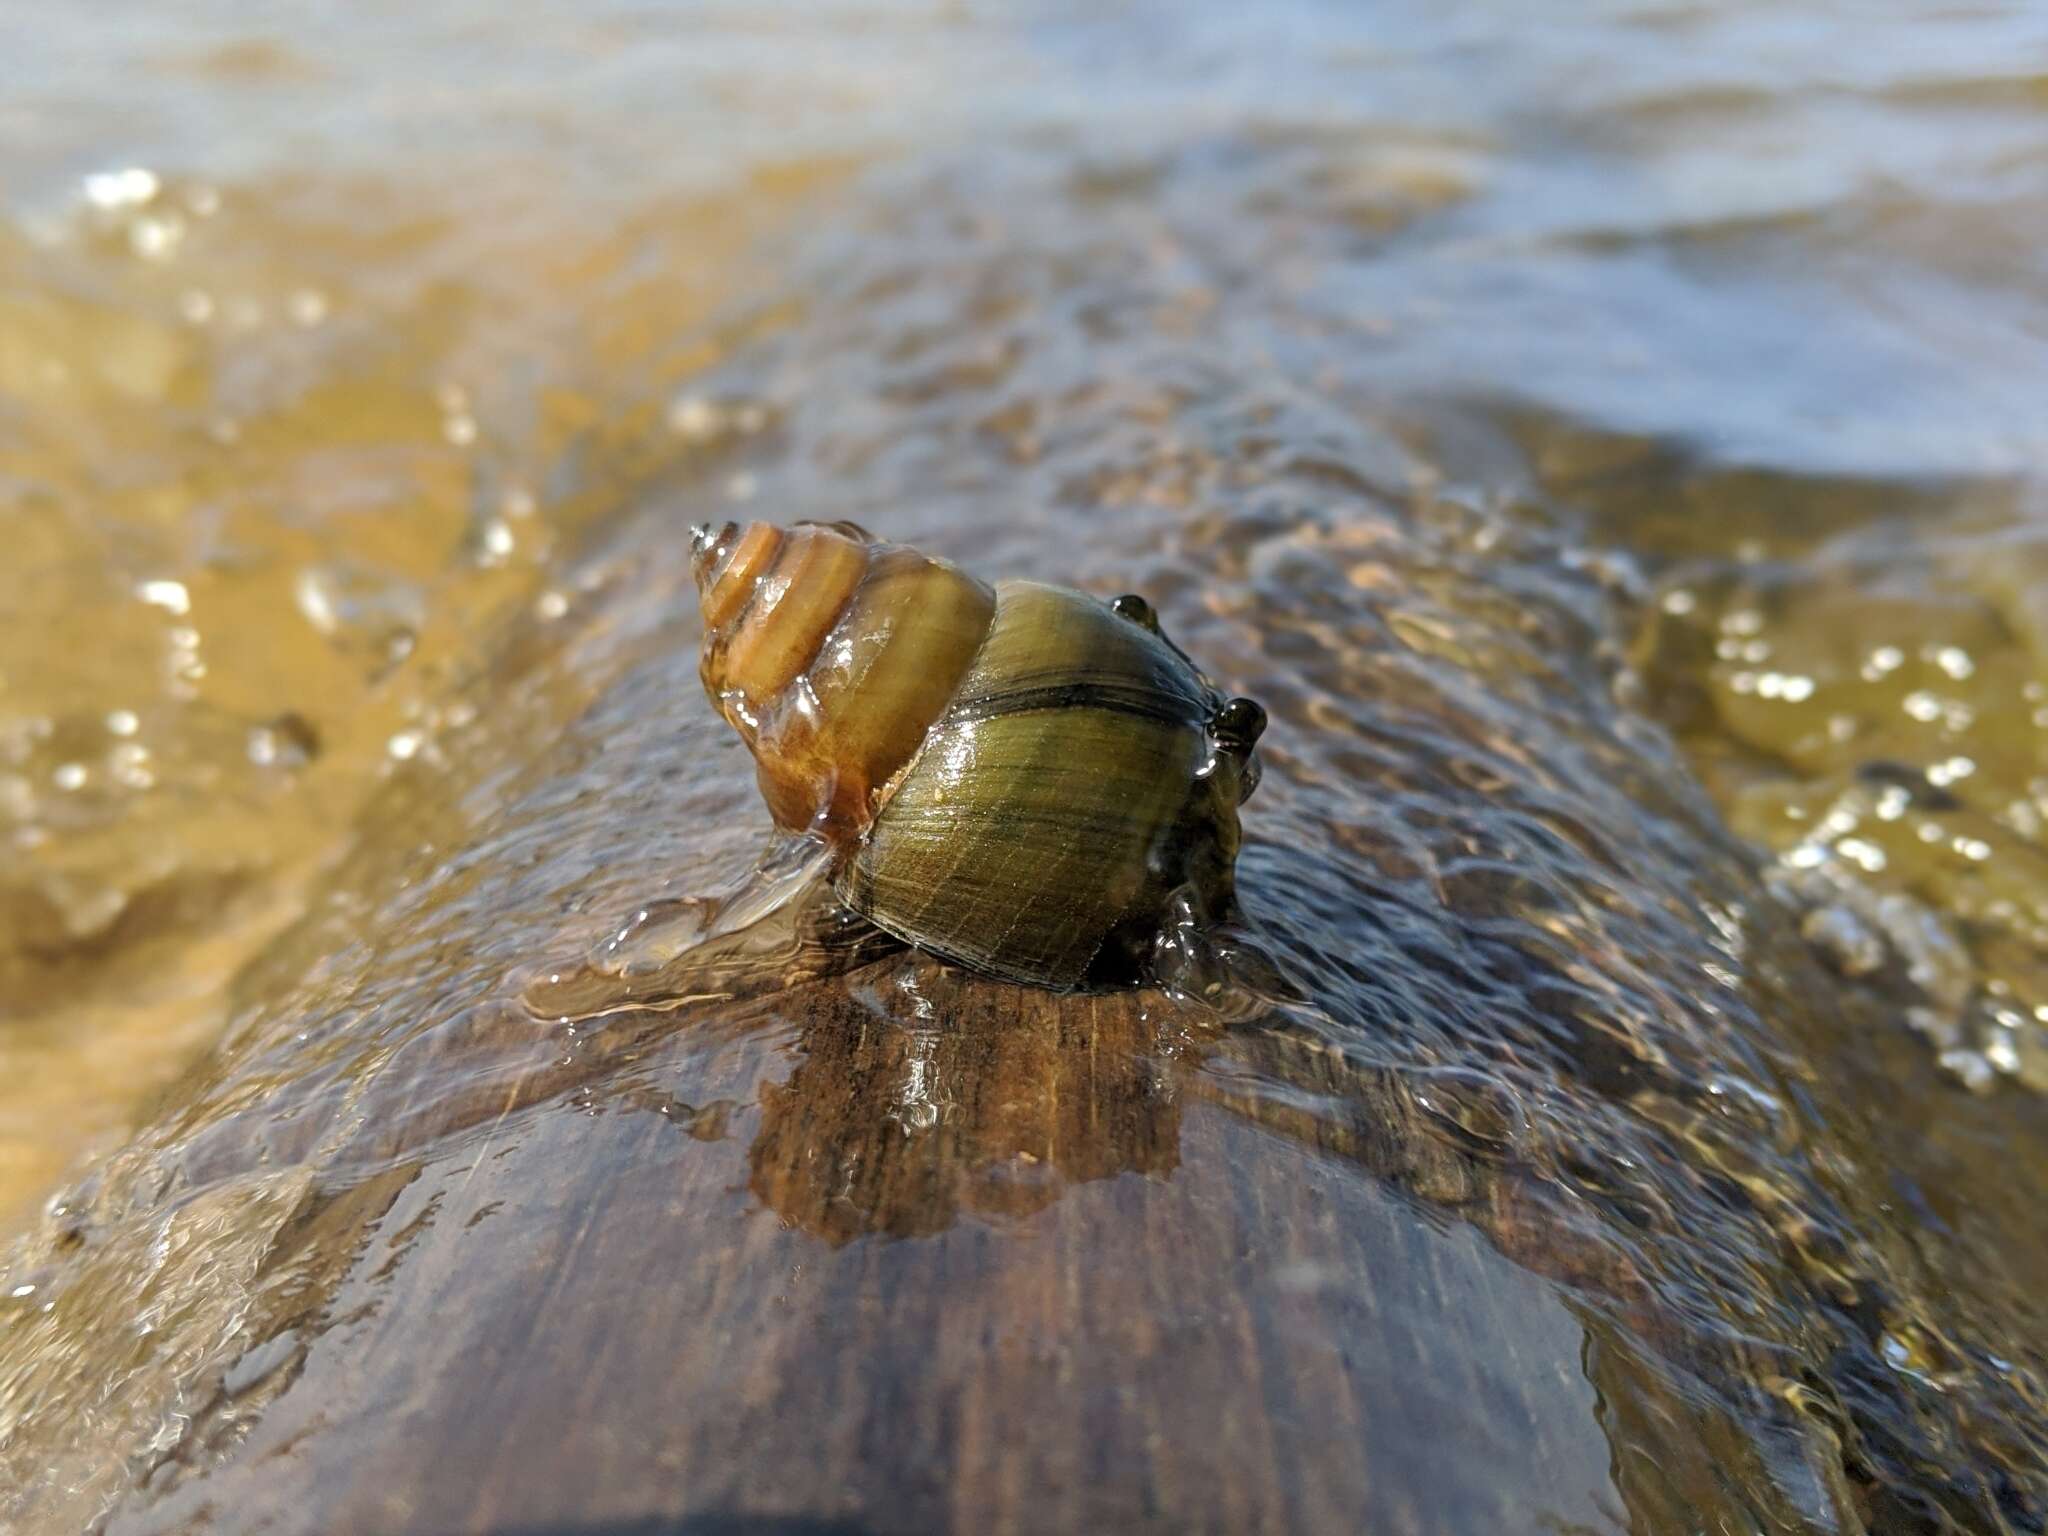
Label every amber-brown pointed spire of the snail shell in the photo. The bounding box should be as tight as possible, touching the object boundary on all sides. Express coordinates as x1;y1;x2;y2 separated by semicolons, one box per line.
690;522;995;848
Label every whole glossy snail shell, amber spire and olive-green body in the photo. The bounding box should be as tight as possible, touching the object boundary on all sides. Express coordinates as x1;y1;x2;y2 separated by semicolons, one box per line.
692;522;1266;989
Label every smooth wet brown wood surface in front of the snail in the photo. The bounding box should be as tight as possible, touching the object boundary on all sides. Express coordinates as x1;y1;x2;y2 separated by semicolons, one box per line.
111;958;1622;1534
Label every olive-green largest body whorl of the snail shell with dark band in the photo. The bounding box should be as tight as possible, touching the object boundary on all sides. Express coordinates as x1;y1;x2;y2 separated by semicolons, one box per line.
838;582;1241;987
